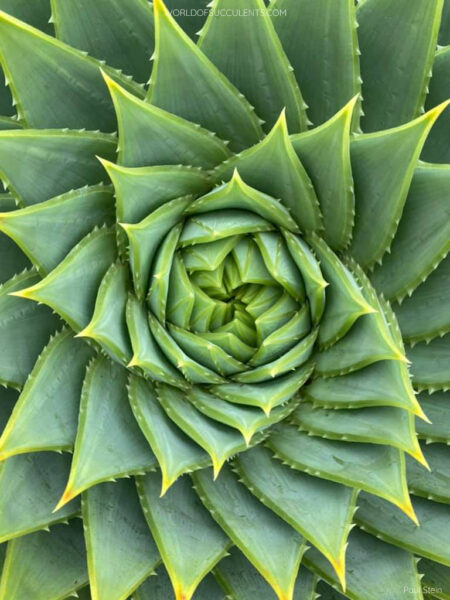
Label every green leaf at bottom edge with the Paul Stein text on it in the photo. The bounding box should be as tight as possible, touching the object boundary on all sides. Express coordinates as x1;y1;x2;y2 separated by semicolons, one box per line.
304;528;423;600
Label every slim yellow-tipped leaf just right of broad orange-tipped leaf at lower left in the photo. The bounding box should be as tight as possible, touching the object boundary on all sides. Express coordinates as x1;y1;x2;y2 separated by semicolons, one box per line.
129;376;210;495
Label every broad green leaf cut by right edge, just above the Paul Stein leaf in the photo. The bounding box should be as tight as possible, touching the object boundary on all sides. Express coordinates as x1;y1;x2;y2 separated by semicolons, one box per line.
355;493;450;566
